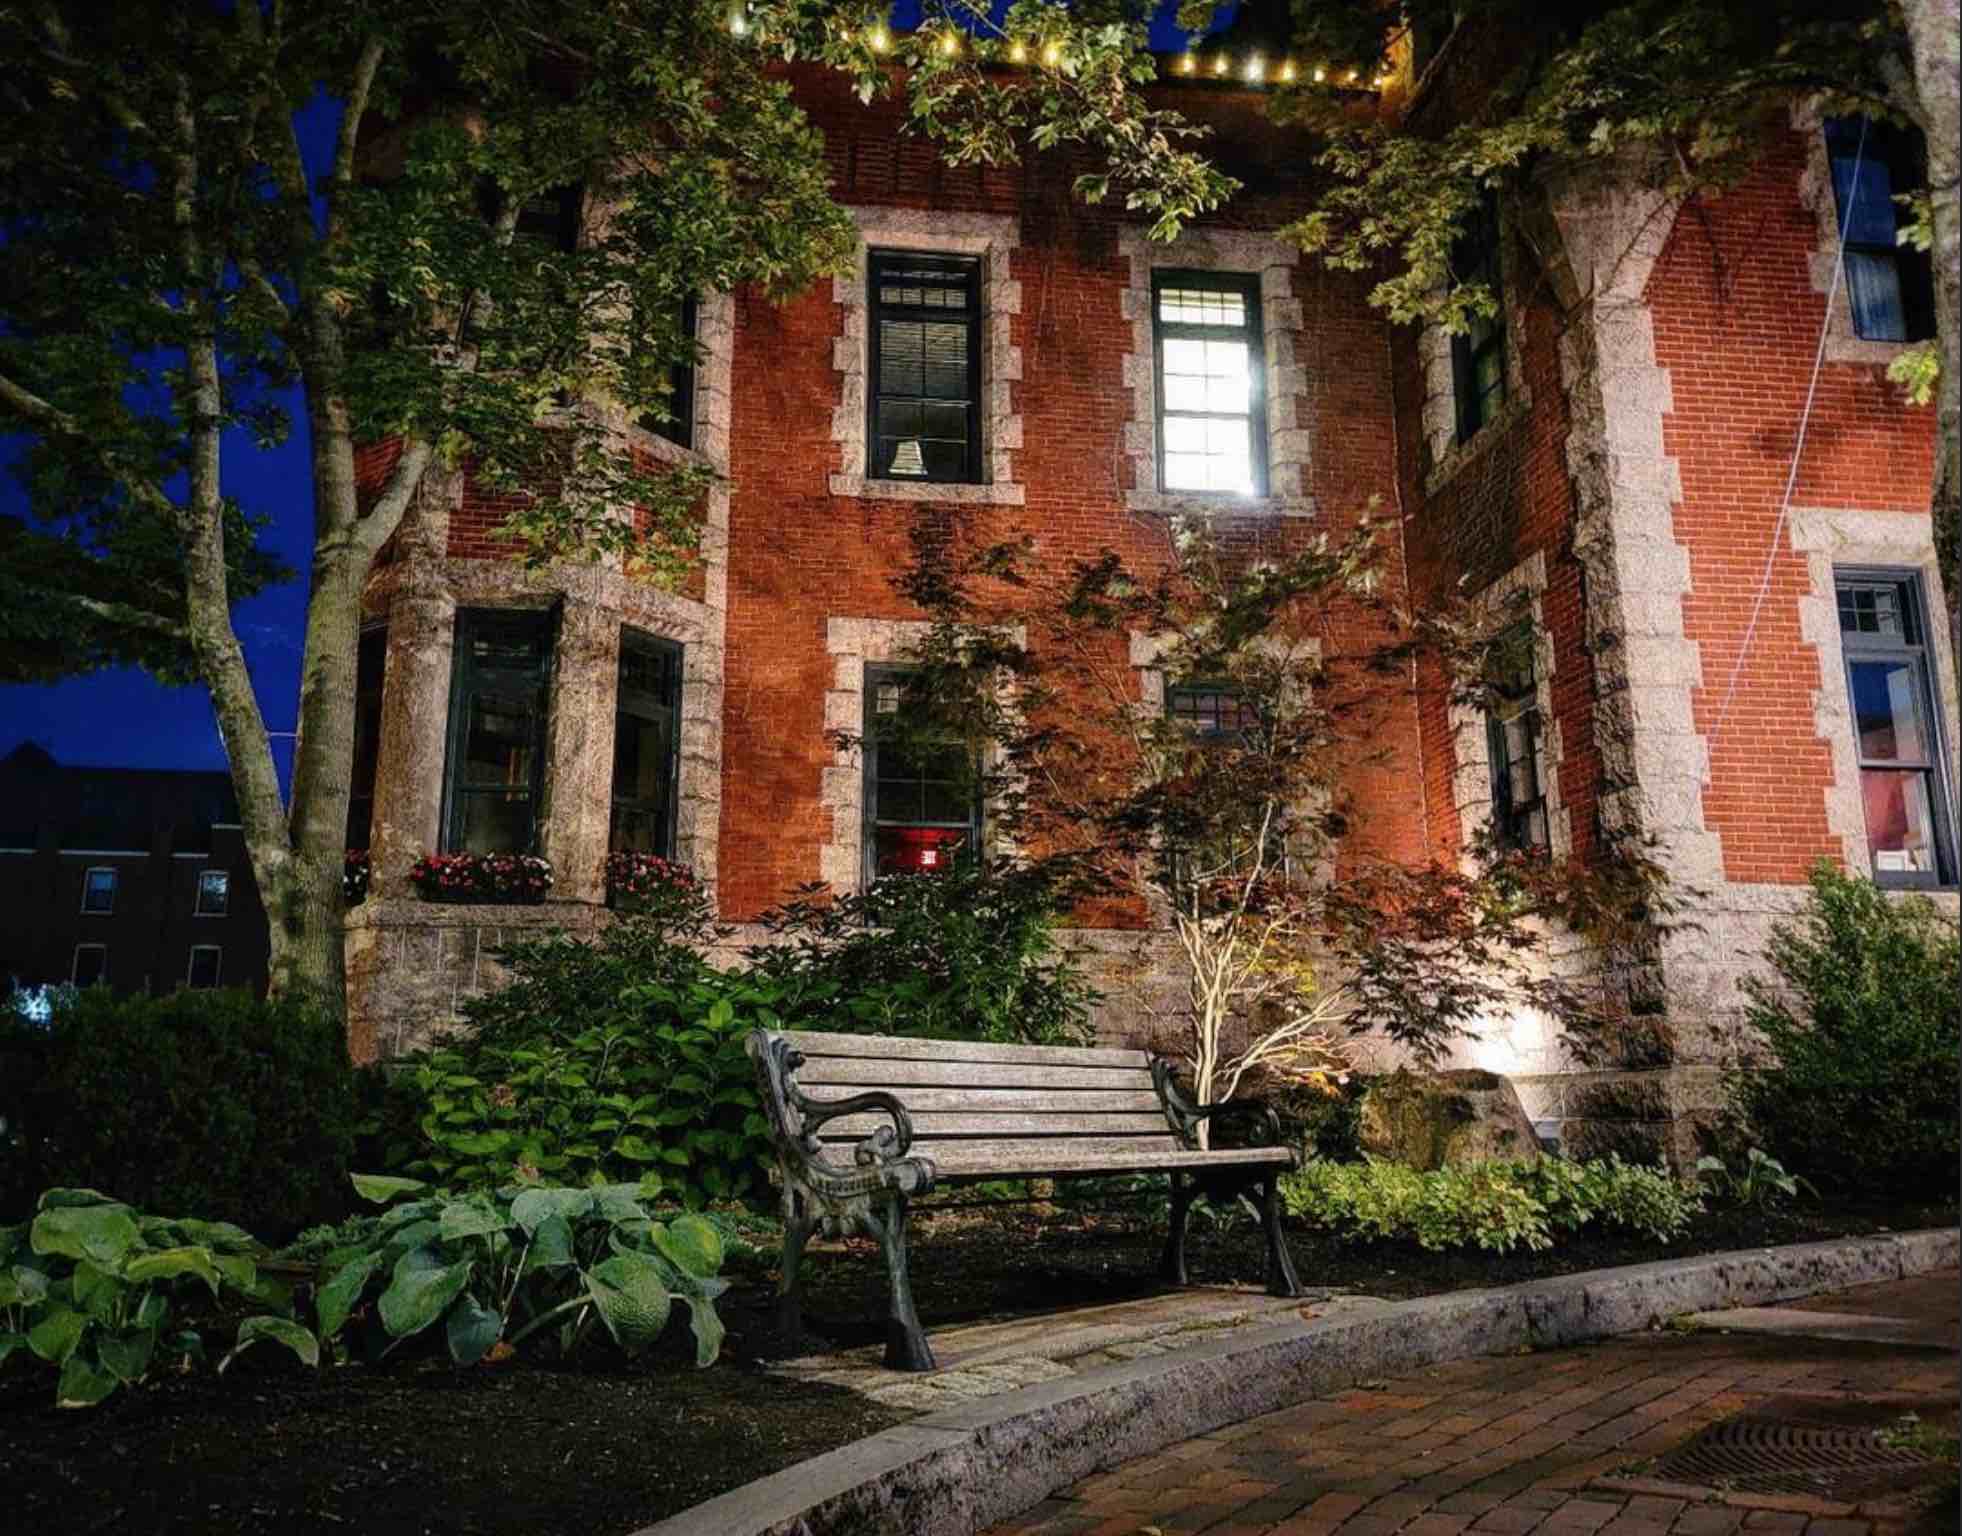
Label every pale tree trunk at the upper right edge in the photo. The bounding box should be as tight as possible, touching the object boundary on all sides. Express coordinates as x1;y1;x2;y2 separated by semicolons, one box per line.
1901;0;1962;657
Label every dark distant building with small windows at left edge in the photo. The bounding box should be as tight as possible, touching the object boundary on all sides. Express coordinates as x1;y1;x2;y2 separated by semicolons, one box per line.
0;742;267;993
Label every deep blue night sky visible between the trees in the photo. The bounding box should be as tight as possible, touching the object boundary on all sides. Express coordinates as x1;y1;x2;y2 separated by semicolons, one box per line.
0;0;1230;792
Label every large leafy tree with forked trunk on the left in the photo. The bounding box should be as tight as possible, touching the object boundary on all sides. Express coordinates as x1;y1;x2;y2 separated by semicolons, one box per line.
0;0;1232;1000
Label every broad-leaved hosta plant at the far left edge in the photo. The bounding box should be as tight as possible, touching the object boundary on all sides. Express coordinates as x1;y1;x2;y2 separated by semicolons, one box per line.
0;1189;320;1408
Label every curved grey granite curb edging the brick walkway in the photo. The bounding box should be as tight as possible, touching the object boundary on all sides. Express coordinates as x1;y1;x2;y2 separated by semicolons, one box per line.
634;1228;1962;1536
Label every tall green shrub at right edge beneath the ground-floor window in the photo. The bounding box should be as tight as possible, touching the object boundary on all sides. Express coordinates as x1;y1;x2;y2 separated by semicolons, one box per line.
1732;865;1962;1201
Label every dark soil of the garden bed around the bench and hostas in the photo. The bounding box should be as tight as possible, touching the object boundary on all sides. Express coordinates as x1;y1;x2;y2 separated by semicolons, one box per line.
0;1204;1956;1536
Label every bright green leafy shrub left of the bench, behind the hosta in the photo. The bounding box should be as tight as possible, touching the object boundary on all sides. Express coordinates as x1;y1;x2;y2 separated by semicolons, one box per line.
377;918;783;1206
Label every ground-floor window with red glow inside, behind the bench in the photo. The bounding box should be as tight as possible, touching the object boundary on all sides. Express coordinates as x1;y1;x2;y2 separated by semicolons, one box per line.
863;667;981;879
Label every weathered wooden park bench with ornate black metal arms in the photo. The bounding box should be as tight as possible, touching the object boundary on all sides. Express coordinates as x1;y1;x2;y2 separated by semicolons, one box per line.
748;1030;1301;1371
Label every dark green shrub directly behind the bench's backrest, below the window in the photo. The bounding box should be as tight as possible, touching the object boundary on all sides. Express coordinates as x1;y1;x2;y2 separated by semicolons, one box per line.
749;859;1099;1046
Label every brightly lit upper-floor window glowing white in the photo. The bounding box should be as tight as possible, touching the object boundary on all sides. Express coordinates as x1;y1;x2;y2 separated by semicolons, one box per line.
1152;271;1267;496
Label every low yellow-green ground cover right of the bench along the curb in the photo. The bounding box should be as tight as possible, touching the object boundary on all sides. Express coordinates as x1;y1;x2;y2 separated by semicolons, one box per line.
1281;1157;1701;1254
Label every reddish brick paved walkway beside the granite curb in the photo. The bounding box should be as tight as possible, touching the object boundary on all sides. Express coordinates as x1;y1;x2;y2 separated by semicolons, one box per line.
991;1271;1958;1536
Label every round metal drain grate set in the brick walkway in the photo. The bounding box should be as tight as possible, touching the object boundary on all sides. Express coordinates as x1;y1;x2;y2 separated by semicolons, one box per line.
1654;1414;1935;1503
